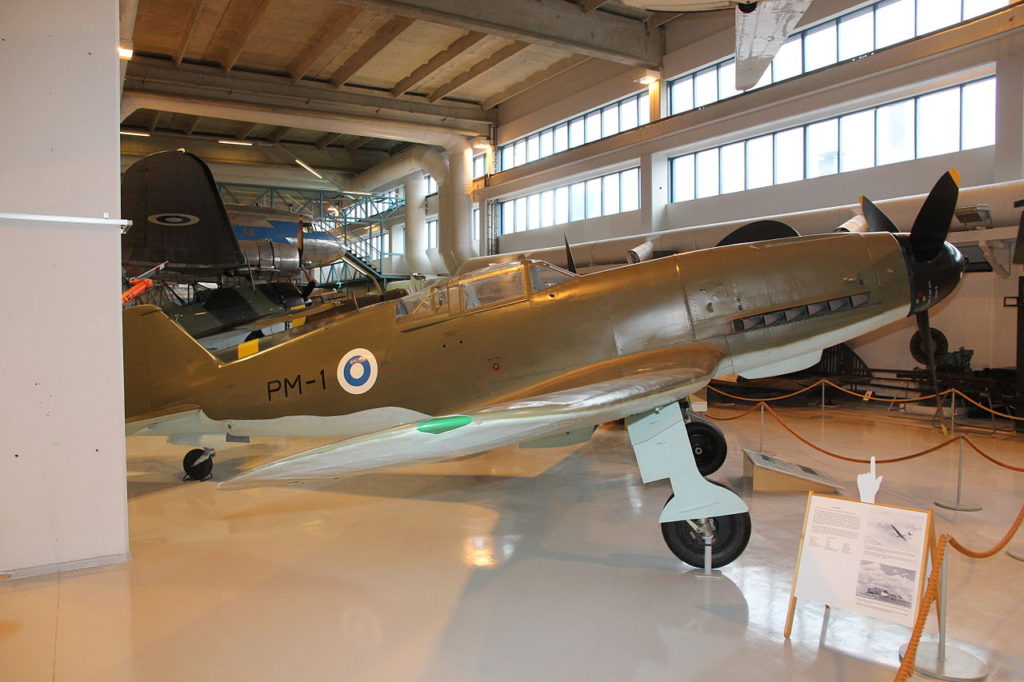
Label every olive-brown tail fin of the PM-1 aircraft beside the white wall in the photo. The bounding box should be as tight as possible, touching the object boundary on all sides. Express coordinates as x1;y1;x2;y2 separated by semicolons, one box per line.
122;305;220;420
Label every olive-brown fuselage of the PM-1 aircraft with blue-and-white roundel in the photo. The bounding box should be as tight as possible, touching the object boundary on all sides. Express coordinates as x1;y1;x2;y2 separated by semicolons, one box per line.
127;233;910;435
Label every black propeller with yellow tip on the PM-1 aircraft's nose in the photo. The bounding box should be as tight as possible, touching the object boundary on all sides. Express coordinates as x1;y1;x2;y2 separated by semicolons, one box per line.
860;170;963;422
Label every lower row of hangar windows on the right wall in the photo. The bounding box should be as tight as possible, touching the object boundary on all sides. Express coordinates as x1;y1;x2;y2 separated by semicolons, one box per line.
499;77;995;235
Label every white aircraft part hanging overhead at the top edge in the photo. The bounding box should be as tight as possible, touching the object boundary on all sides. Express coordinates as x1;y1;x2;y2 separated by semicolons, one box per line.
623;0;811;90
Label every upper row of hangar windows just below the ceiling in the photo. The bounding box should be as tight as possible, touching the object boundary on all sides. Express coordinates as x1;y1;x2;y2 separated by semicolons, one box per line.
495;0;1008;177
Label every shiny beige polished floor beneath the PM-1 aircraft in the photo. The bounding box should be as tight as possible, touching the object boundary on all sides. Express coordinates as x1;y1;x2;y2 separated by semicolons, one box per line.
0;406;1024;682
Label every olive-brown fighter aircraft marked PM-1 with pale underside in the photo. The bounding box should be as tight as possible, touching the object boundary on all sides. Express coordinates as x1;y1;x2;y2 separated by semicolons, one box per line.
124;172;964;566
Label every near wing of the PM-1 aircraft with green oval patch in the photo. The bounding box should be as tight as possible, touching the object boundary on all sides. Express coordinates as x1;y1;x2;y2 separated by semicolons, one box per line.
219;347;722;488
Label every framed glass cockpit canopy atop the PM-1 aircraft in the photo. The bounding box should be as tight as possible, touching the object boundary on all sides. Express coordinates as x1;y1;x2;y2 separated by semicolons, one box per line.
395;260;578;323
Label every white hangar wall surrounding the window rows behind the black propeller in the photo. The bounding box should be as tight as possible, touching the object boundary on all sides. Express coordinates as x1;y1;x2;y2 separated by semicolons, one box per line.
478;0;1024;368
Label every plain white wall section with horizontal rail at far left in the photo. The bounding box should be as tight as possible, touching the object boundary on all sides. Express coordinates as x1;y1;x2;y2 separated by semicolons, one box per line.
0;0;128;576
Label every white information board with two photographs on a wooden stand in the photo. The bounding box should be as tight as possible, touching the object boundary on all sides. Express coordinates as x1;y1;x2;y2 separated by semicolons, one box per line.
786;495;932;635
